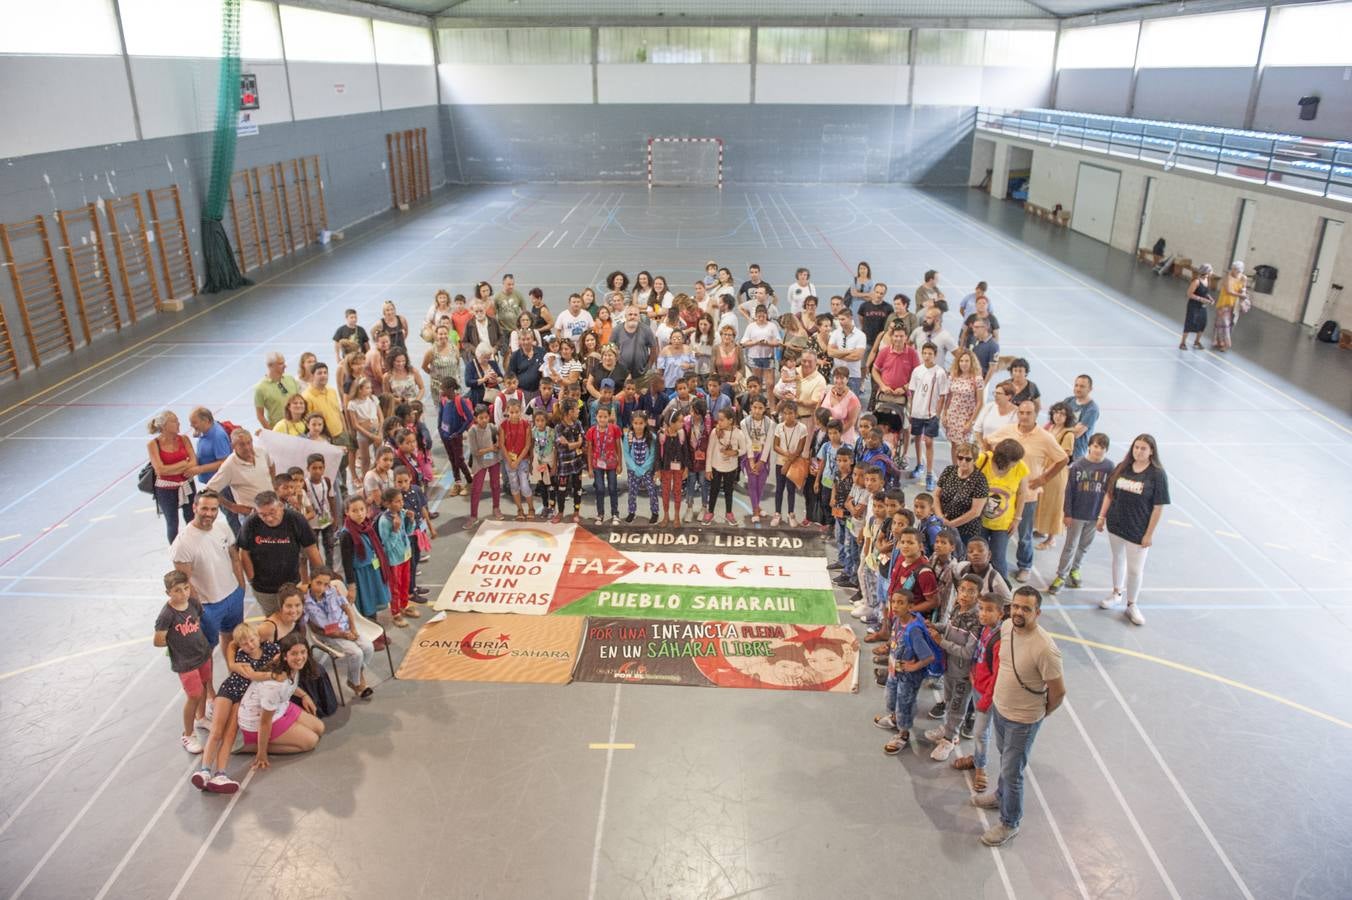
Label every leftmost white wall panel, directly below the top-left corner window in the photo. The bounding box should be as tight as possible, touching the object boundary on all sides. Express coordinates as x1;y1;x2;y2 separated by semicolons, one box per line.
0;55;137;158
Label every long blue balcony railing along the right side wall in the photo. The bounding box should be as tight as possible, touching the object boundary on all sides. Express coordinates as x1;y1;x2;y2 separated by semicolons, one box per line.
976;107;1352;203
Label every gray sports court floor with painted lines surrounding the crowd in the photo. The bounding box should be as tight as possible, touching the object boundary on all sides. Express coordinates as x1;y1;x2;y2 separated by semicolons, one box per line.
0;185;1352;900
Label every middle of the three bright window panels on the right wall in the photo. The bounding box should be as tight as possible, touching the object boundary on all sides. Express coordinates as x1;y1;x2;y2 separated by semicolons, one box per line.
1137;9;1265;69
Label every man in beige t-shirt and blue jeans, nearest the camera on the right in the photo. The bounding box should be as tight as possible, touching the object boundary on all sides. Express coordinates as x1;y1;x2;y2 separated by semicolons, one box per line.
972;585;1065;847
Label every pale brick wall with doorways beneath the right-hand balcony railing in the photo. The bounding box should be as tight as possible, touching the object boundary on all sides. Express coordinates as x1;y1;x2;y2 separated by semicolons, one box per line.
980;132;1352;322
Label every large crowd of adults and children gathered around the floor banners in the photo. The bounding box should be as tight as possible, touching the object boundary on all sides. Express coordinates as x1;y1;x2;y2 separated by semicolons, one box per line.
147;261;1168;827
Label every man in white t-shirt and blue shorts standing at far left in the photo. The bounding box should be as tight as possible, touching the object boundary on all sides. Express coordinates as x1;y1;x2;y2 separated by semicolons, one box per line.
169;488;245;665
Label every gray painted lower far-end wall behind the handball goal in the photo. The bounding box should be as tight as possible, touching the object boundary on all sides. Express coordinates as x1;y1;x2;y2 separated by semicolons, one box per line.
442;104;976;185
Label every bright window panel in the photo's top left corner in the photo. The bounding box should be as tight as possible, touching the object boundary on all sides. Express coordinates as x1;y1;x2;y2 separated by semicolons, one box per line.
0;0;122;55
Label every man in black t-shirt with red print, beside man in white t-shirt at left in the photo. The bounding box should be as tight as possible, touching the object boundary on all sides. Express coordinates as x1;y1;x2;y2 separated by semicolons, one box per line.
235;491;323;615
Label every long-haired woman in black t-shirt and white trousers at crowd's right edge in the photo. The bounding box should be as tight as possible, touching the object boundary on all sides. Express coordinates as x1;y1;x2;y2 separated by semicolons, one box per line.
1095;434;1169;624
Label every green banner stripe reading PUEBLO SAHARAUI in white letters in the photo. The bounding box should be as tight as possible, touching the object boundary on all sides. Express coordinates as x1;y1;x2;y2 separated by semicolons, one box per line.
557;582;840;624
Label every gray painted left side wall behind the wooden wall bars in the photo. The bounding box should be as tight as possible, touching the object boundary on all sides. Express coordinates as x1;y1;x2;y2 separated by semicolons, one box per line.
0;107;445;366
